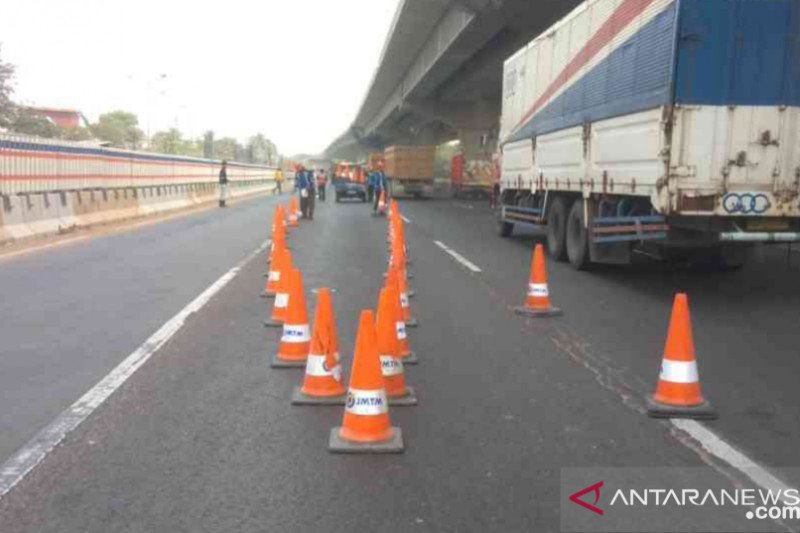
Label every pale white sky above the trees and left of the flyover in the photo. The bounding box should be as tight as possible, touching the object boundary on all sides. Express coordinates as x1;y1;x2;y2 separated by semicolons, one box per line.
0;0;398;155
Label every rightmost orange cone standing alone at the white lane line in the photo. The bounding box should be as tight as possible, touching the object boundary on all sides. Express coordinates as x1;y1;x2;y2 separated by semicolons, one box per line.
647;293;717;420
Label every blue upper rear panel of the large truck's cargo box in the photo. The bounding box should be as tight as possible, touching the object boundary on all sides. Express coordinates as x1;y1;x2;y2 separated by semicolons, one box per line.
675;0;800;106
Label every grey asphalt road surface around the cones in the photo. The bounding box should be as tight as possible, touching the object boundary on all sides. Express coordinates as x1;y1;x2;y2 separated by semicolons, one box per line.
0;193;800;532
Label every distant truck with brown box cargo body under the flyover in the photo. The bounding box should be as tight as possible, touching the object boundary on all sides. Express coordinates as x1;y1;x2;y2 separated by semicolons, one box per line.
384;145;436;198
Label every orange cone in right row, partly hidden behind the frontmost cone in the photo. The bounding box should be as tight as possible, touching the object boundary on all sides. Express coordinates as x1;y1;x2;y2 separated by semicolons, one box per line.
376;289;417;405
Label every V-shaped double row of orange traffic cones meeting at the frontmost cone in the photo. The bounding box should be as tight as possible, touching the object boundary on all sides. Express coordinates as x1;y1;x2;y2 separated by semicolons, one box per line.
264;197;417;452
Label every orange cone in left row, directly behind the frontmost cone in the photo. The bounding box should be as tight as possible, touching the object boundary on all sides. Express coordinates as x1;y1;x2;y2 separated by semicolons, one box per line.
292;289;347;405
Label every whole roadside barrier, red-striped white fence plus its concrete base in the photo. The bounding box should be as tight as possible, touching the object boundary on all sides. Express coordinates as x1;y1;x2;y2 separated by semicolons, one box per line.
0;133;276;242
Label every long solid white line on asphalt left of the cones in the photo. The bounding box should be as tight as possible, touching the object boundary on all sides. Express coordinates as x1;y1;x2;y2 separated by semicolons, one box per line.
0;241;269;498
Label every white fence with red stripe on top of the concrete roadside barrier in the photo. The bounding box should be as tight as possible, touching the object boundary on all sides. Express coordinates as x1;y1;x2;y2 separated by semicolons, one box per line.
0;133;277;195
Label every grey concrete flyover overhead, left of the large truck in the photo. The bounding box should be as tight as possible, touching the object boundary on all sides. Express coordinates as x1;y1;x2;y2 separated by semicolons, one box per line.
326;0;580;159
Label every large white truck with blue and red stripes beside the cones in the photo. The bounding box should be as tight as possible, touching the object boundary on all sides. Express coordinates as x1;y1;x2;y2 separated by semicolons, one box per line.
498;0;800;269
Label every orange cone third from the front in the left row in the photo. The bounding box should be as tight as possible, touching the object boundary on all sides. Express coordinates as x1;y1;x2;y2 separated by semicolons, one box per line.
272;269;311;368
